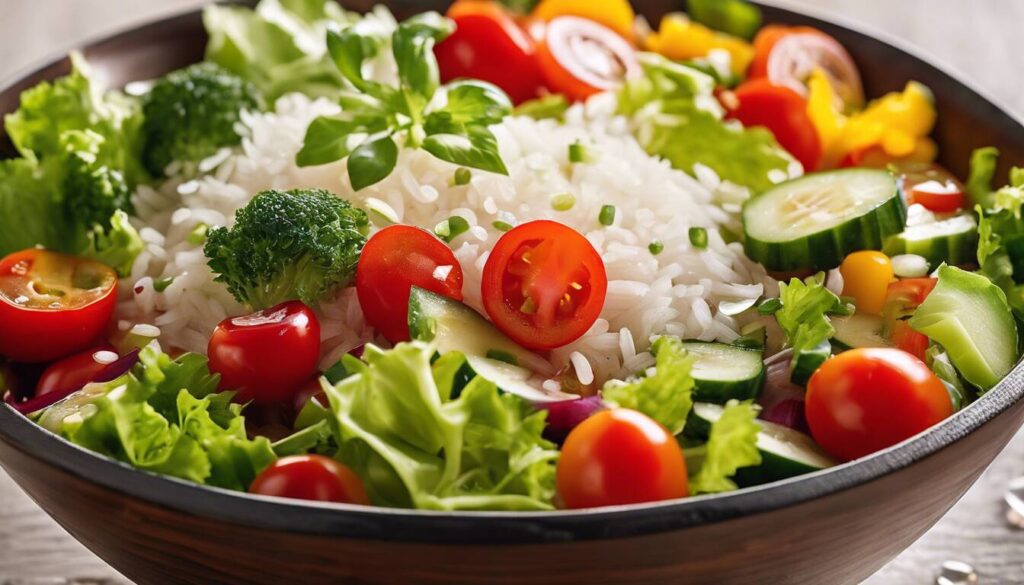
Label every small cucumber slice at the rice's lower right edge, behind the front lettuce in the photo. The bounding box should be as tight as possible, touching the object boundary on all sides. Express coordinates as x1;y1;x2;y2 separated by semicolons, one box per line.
683;341;765;404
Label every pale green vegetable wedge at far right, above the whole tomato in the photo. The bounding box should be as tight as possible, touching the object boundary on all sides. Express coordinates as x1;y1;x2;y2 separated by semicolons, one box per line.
910;266;1020;392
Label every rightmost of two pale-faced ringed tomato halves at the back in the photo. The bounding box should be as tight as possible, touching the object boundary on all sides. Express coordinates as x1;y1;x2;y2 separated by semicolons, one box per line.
749;25;864;112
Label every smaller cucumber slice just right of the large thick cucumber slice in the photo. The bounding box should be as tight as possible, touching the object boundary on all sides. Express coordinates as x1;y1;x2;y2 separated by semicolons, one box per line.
883;213;978;266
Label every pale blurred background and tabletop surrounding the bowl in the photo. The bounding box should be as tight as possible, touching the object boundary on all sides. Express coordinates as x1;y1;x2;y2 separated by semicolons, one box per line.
0;0;1024;585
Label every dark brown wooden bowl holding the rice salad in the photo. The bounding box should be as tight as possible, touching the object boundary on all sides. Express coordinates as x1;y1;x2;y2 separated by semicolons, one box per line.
0;0;1024;585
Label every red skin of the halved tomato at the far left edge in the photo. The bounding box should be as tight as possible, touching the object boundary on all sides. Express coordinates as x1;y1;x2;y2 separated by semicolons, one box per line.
0;249;118;364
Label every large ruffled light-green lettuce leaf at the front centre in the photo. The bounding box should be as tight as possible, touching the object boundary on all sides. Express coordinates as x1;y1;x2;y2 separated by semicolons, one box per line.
326;342;558;510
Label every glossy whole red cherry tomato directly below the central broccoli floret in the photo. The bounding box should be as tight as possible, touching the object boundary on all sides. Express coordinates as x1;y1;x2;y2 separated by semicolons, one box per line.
207;300;319;405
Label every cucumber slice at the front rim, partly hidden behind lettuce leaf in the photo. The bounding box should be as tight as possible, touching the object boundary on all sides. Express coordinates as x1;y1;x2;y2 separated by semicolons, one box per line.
684;403;836;487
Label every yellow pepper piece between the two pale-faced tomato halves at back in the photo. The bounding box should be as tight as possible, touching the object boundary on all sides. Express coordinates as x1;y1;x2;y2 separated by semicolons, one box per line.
647;14;754;75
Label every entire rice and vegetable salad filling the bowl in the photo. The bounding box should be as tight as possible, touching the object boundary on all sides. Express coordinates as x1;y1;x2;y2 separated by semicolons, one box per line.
0;0;1024;511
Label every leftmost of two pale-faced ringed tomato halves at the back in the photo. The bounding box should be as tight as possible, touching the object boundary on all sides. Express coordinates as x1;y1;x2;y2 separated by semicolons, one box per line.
537;16;640;101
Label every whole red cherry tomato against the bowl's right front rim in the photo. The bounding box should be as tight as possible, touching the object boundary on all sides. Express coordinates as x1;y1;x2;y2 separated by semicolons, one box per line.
806;347;953;461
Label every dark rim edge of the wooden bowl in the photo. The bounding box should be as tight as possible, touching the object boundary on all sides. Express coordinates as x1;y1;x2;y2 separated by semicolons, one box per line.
0;2;1024;544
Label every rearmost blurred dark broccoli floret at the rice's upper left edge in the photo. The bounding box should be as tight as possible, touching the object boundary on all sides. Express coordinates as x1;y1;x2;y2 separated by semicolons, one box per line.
142;62;262;177
